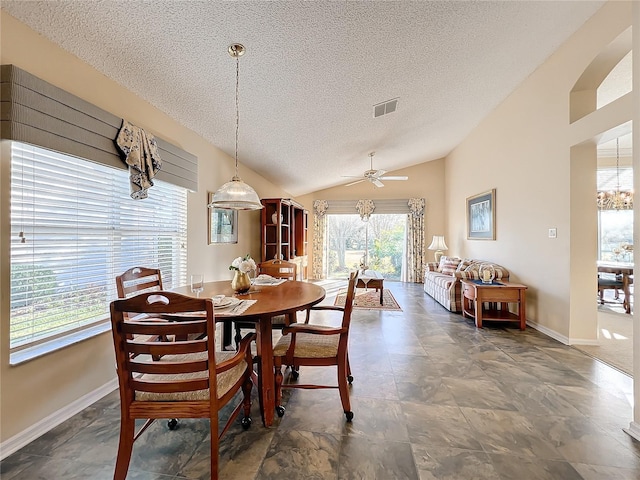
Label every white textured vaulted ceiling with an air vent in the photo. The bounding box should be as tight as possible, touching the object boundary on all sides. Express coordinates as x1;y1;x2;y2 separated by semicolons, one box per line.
1;0;605;196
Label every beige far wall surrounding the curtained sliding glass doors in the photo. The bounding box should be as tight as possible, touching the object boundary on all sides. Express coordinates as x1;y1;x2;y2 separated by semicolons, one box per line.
298;159;444;275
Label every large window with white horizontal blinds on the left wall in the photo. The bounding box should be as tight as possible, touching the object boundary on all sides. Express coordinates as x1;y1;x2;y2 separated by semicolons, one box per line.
10;142;187;363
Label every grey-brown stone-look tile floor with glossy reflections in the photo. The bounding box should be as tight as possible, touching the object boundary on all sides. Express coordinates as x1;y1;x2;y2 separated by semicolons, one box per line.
0;283;640;480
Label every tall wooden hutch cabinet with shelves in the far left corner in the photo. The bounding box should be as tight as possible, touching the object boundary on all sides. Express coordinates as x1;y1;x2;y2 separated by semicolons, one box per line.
261;198;309;280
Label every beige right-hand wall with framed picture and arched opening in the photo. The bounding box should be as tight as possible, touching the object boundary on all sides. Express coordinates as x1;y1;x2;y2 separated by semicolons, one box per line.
445;2;632;341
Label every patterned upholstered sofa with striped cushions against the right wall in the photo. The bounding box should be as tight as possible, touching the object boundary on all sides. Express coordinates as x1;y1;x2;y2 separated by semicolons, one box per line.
424;256;509;313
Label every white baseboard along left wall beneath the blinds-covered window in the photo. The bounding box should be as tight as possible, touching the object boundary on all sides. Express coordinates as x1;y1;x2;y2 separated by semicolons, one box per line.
0;378;118;460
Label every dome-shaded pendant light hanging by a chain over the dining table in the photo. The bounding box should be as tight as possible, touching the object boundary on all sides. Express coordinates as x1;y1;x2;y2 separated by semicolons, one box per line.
208;43;263;210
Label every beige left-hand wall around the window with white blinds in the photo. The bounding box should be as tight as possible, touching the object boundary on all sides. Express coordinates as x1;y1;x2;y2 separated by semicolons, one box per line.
0;12;288;442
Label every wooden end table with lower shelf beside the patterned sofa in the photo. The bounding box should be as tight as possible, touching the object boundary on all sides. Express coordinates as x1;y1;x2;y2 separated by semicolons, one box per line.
462;280;527;330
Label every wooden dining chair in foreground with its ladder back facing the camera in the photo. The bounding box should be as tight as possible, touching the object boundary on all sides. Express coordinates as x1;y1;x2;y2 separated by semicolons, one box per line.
111;291;255;480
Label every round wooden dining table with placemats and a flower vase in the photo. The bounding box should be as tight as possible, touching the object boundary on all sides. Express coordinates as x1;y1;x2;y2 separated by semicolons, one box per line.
172;280;326;427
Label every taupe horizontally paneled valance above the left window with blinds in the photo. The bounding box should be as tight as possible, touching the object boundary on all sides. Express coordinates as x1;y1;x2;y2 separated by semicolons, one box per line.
0;65;198;191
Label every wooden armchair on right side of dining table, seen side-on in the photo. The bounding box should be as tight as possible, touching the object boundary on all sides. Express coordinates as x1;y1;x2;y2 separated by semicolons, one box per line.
273;271;358;422
